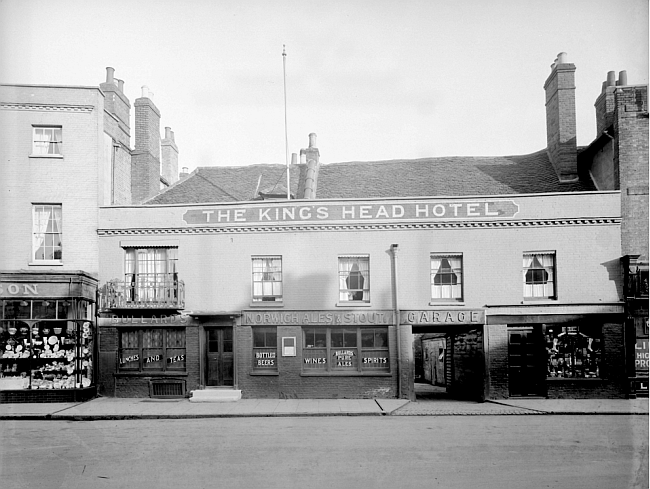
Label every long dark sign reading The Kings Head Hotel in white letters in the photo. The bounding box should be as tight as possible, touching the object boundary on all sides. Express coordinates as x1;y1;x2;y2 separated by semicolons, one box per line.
183;200;519;226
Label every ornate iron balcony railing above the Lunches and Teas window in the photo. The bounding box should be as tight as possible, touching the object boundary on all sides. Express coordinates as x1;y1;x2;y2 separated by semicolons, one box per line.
99;277;185;310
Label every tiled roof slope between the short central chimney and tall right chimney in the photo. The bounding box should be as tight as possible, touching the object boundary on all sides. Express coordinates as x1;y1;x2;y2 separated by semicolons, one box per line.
316;150;595;199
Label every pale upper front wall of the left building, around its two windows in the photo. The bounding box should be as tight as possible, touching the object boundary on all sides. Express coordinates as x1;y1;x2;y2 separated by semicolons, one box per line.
0;85;104;274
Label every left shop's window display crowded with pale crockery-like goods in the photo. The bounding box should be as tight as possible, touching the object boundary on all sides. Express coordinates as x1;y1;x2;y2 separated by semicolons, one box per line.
0;300;93;390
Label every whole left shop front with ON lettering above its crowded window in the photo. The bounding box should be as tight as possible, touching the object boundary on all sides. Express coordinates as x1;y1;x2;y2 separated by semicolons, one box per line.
0;272;97;403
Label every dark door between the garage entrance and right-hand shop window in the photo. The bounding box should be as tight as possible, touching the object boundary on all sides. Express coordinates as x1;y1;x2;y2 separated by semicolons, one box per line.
508;327;545;396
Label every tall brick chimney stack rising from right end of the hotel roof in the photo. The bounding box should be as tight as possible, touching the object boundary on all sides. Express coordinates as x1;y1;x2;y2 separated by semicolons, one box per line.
544;53;578;183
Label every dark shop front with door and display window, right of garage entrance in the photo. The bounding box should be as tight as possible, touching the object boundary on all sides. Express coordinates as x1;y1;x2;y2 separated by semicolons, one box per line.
486;304;626;399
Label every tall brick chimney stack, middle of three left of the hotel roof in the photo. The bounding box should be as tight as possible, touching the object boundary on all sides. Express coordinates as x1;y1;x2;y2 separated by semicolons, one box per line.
131;85;160;204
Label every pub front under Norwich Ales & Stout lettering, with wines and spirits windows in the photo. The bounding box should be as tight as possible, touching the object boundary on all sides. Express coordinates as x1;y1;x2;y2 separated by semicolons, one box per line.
236;309;399;399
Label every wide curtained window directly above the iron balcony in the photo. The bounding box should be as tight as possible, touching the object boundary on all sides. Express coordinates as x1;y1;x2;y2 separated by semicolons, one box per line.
124;248;179;304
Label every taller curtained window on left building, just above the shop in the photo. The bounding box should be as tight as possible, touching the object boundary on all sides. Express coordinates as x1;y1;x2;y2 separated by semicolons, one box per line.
32;204;63;262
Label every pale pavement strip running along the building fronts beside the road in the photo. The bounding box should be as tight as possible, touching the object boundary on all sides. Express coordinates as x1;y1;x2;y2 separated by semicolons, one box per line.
0;397;648;421
